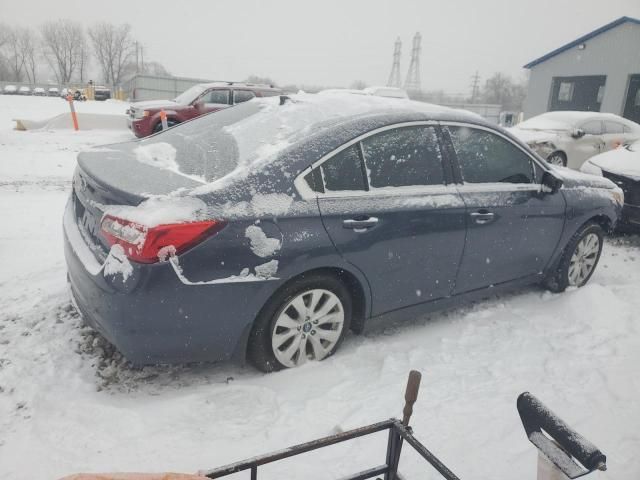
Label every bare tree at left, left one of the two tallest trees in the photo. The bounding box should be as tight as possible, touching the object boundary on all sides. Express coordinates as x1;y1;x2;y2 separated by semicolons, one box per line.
41;20;84;83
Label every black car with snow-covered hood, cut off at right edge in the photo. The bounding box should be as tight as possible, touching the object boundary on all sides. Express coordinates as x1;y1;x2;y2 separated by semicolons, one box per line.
580;141;640;230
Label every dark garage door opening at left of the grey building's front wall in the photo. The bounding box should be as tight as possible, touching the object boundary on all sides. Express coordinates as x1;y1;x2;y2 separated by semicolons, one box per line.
549;75;607;112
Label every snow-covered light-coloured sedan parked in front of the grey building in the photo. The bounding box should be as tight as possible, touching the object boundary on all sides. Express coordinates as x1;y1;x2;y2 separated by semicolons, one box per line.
509;111;640;170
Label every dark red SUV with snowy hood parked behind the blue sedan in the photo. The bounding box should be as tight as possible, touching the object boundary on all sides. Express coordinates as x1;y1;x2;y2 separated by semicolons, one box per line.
127;82;282;137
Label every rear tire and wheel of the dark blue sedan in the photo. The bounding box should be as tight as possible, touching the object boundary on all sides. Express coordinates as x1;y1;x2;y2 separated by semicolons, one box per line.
247;274;353;372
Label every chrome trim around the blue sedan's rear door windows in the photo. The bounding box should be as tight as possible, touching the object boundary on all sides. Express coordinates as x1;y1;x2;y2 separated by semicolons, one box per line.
293;120;440;200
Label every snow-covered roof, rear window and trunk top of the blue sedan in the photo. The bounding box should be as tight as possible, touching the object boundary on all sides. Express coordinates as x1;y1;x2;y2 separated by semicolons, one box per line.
78;93;489;199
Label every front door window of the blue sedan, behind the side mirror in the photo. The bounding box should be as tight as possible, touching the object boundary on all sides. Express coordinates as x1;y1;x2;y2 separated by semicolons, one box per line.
448;126;535;183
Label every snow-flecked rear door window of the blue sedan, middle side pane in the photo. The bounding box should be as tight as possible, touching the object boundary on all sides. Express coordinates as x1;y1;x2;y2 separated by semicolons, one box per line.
362;126;444;188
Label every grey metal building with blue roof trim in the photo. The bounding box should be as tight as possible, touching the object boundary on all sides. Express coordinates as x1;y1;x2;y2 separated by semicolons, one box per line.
524;17;640;122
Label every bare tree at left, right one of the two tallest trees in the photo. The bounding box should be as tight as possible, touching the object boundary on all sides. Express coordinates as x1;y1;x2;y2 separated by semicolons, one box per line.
89;22;135;85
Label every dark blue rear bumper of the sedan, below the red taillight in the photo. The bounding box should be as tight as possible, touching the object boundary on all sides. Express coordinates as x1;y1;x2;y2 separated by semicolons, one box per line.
64;202;259;365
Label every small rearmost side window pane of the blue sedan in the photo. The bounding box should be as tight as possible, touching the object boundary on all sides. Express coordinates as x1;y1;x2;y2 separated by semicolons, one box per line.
320;143;367;192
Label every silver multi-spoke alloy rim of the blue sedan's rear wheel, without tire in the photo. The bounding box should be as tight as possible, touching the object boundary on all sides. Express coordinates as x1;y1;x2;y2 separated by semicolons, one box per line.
271;289;344;368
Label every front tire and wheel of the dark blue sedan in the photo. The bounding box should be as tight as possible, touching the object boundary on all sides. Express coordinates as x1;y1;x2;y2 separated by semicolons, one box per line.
545;222;604;293
